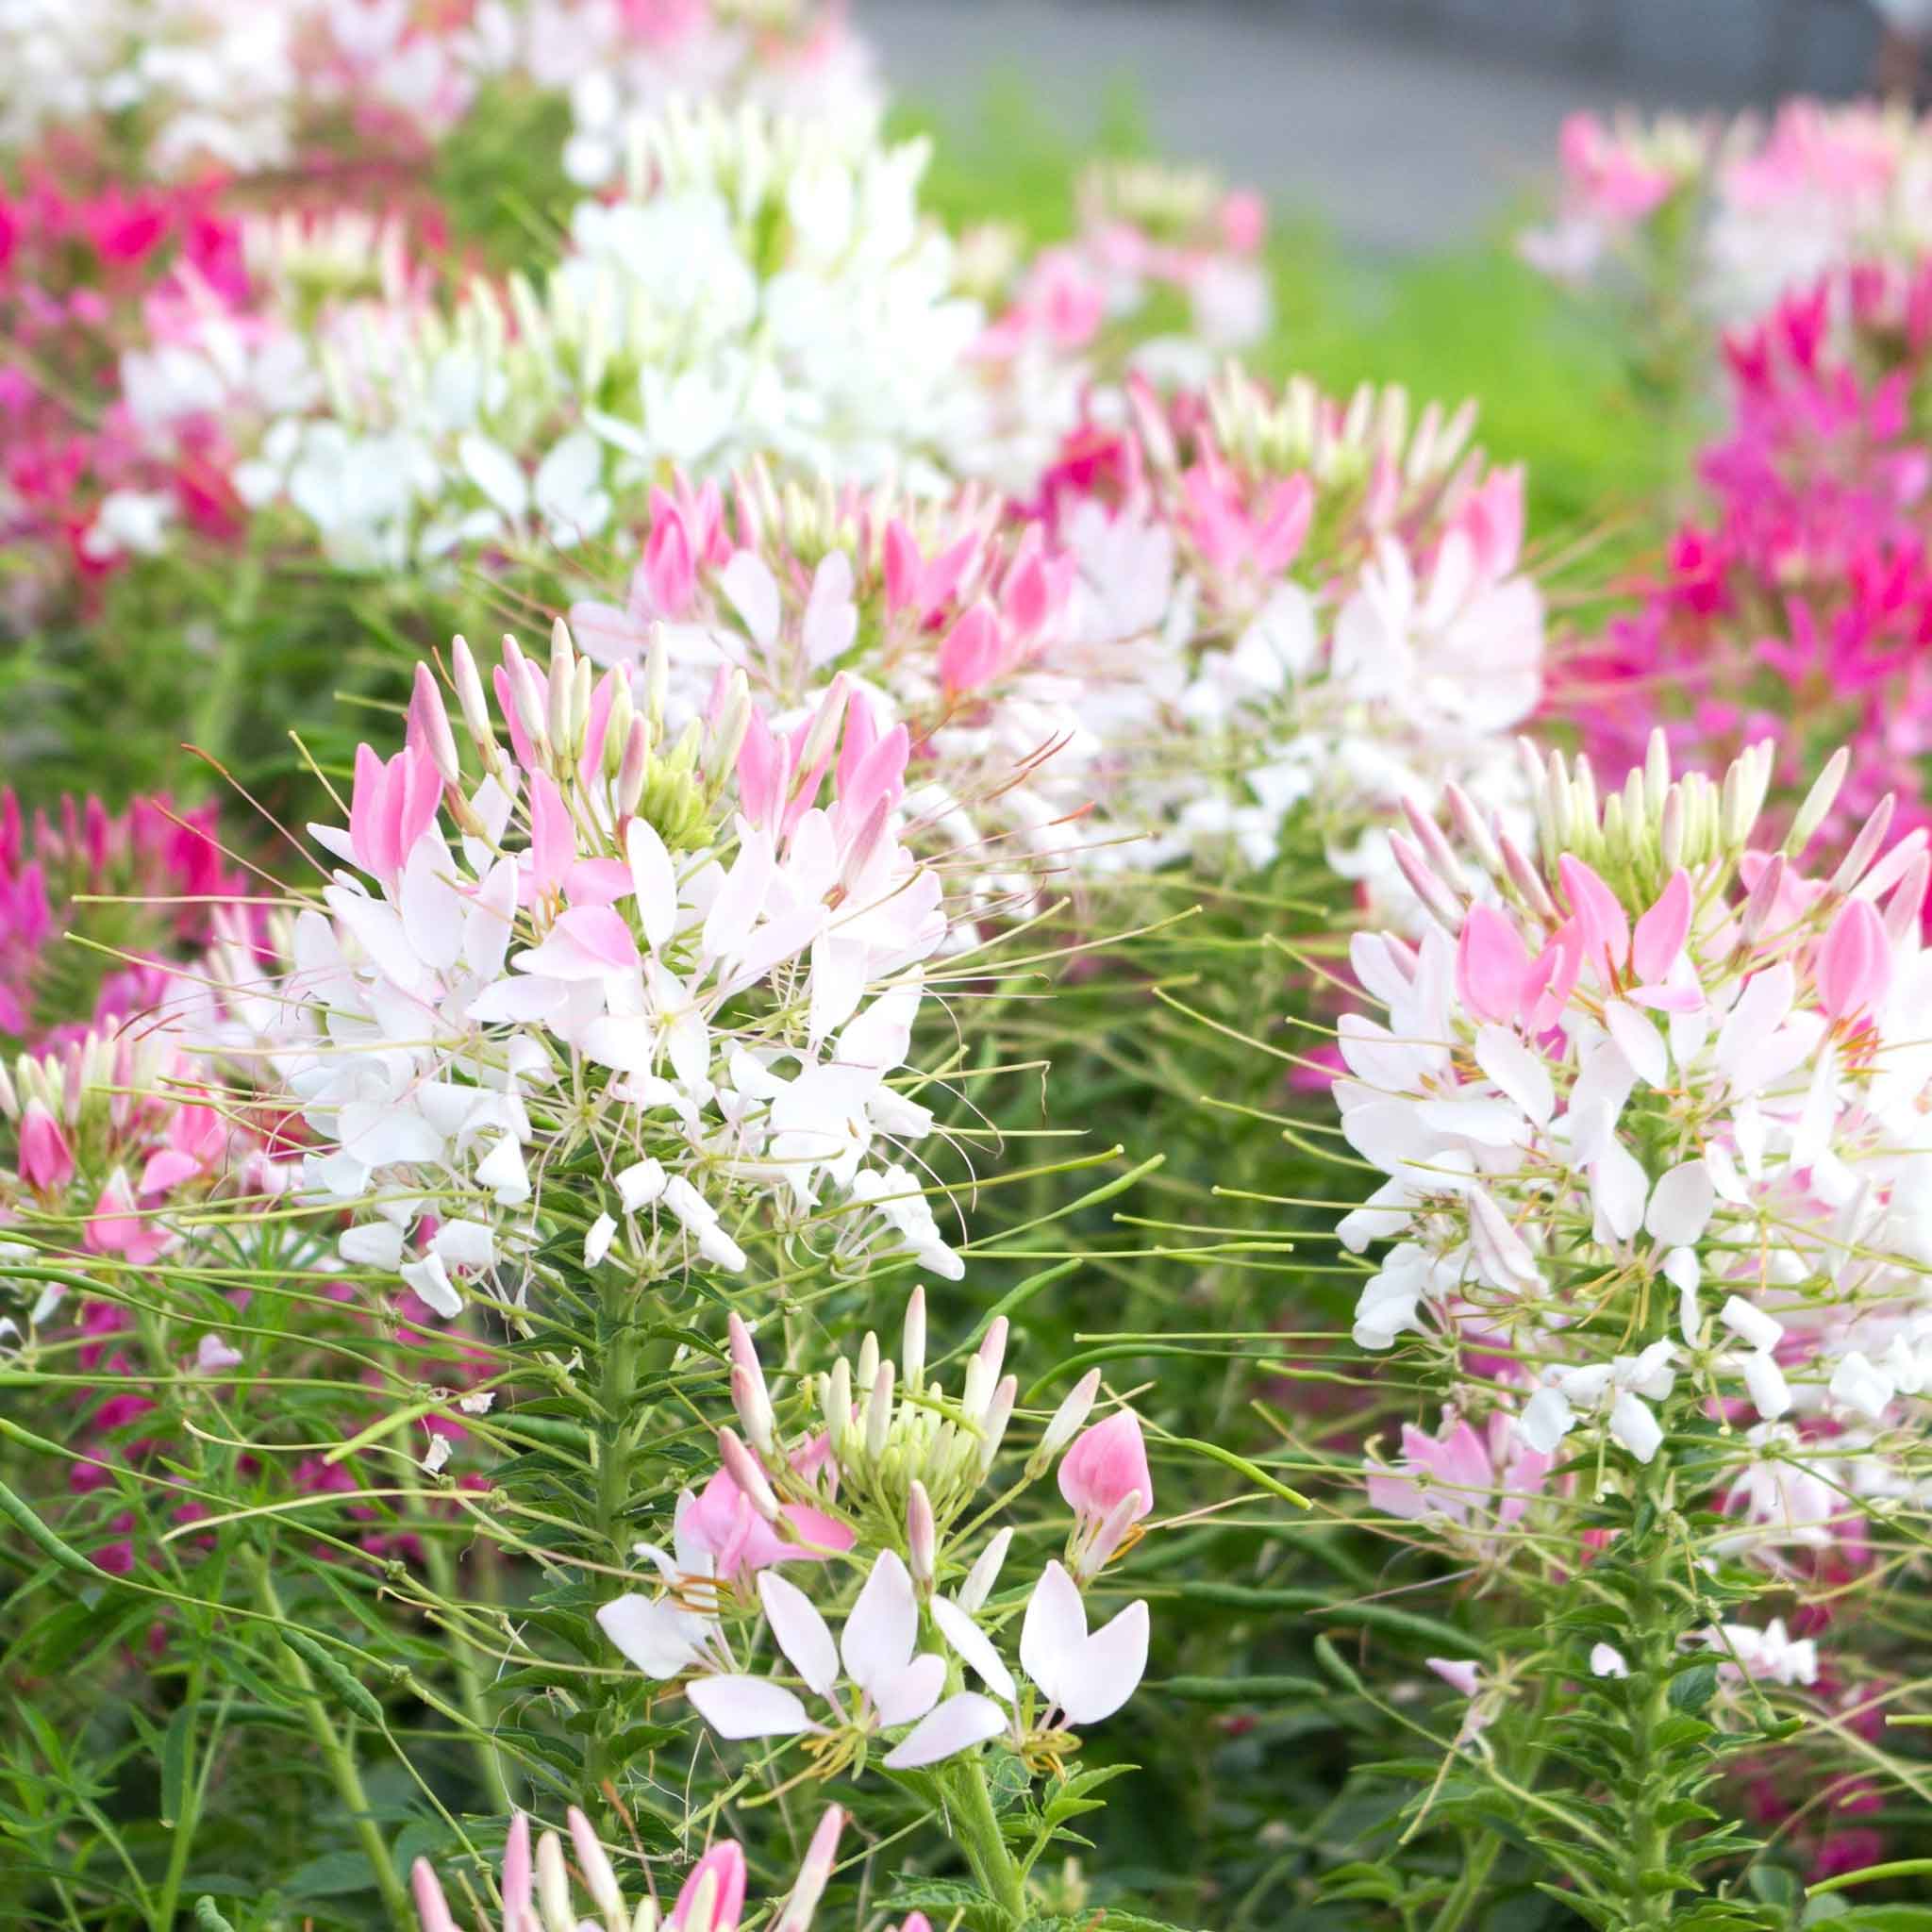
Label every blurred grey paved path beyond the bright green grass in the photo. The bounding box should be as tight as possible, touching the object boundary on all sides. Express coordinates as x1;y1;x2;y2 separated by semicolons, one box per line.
854;0;1862;253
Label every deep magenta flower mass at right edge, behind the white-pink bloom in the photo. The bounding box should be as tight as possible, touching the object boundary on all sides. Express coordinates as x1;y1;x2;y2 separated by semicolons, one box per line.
1552;265;1932;854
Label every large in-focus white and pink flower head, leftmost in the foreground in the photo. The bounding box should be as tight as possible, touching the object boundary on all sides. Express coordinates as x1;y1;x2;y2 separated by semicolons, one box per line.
269;625;960;1314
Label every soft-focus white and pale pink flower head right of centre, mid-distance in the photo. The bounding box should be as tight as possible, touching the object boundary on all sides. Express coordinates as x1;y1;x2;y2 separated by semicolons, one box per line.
1040;369;1543;896
